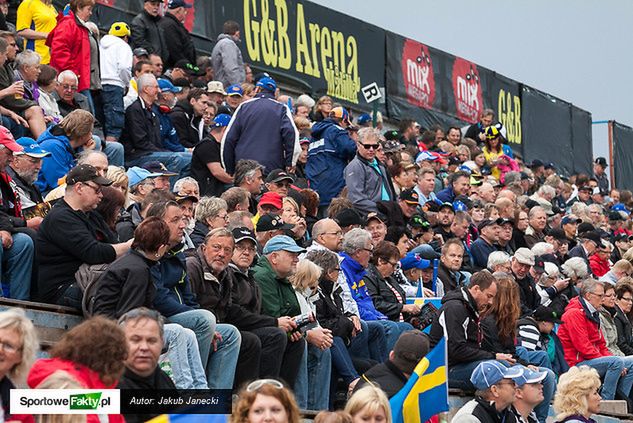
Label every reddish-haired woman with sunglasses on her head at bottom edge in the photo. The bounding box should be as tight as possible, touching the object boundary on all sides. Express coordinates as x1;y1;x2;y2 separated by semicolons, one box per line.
229;379;301;423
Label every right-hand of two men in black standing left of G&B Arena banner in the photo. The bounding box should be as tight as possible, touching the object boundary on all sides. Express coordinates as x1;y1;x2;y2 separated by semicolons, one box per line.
158;0;196;69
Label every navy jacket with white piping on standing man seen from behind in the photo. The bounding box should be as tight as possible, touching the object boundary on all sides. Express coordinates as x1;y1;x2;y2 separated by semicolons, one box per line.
220;92;301;175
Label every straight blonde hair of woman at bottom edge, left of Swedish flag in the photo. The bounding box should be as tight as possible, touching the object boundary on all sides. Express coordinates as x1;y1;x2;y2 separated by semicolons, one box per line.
345;385;391;423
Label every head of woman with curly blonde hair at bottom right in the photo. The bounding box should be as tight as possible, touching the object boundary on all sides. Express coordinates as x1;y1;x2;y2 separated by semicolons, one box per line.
554;366;602;423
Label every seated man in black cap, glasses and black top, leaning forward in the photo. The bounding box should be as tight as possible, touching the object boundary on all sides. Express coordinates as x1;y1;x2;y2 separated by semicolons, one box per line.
36;165;132;310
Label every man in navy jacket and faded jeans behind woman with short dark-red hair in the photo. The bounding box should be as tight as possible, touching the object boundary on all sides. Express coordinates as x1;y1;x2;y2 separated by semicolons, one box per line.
147;201;241;389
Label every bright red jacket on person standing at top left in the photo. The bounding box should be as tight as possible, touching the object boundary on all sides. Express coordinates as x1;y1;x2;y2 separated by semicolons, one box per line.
46;11;90;91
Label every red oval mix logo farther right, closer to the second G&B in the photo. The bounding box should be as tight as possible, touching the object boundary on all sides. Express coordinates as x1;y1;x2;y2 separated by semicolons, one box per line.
453;57;484;123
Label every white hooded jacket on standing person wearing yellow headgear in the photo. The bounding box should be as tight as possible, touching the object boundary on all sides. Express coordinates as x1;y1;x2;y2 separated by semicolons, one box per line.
99;34;133;88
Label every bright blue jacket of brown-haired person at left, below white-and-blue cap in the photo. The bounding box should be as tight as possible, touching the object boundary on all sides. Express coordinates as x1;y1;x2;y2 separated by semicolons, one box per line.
35;126;77;196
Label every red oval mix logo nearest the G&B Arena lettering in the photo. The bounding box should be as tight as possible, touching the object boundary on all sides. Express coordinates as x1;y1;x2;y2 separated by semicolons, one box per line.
402;39;435;109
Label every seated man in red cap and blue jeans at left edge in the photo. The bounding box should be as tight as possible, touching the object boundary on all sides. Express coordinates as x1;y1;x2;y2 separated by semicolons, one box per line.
0;126;34;300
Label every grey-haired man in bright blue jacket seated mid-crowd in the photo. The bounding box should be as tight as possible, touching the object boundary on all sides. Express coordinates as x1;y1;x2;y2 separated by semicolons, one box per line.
340;228;413;351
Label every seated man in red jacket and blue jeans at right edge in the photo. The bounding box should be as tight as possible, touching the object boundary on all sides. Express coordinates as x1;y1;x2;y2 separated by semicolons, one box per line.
558;279;633;400
